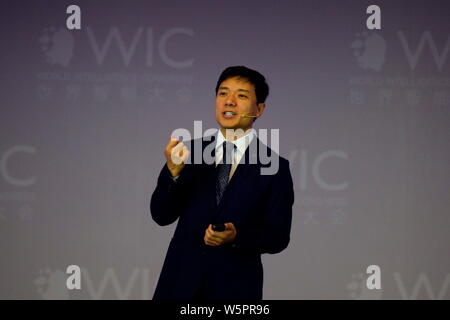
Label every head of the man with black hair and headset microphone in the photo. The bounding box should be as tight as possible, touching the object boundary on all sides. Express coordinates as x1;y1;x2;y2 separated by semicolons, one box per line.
216;66;269;133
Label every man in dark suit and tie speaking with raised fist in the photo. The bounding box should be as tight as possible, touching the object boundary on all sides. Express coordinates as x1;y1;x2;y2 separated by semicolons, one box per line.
150;66;294;300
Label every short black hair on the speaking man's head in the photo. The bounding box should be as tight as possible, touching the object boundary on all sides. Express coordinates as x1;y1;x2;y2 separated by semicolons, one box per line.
216;66;269;103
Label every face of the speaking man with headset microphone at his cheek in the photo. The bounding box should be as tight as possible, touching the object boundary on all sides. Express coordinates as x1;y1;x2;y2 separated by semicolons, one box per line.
216;77;265;133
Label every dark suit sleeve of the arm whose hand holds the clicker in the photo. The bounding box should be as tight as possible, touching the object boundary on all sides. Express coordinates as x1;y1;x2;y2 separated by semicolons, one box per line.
230;158;294;254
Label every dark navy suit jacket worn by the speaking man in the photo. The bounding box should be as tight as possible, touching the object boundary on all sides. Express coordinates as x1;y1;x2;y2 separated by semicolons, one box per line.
150;136;294;300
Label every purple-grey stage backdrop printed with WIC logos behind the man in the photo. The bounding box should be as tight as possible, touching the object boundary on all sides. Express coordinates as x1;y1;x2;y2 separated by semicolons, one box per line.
0;0;450;299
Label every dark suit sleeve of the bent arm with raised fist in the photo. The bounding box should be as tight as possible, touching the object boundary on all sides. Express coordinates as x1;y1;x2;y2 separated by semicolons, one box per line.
150;164;191;226
